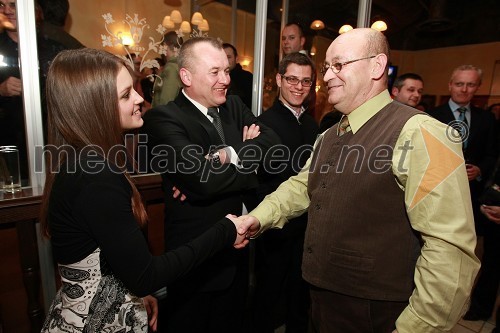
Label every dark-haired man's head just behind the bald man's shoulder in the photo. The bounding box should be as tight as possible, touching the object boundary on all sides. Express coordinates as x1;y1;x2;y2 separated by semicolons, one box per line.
391;73;424;108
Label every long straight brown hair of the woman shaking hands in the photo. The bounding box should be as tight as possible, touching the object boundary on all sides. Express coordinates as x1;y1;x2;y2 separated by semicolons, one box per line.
40;48;147;236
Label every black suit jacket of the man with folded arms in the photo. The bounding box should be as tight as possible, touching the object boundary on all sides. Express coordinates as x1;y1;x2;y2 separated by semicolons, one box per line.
141;92;279;291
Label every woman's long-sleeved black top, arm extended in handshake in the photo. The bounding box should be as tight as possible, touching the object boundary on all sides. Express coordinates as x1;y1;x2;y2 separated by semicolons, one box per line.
48;156;236;296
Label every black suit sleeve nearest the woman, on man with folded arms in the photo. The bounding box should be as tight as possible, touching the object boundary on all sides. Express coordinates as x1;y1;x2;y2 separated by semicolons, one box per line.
142;102;257;201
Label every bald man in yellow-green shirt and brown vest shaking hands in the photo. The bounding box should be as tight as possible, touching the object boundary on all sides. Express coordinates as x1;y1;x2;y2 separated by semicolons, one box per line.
238;28;479;333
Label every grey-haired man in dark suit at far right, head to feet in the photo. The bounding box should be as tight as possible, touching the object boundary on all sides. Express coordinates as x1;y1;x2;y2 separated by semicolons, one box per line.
429;65;499;320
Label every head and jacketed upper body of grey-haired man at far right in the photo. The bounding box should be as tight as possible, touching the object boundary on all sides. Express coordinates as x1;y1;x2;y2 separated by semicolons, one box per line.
428;65;498;237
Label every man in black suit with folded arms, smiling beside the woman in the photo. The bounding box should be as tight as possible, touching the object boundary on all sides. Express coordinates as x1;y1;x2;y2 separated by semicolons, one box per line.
143;37;279;333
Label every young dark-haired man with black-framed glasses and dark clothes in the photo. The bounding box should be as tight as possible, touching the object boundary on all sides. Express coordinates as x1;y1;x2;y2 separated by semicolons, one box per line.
253;52;319;333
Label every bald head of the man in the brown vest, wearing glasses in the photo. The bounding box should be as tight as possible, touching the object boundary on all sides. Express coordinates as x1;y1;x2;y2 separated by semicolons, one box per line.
323;28;389;114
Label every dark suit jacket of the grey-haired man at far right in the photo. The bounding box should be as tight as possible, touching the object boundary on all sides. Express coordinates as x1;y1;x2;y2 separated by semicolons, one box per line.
428;103;498;233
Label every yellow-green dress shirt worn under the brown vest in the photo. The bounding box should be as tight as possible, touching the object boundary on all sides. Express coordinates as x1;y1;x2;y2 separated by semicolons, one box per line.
249;90;480;333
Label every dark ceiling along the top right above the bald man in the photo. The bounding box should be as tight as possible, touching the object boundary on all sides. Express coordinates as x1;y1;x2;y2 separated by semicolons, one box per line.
209;0;500;50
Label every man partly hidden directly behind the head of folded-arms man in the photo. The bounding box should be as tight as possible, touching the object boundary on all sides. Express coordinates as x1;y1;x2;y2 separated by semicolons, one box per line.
222;43;253;110
